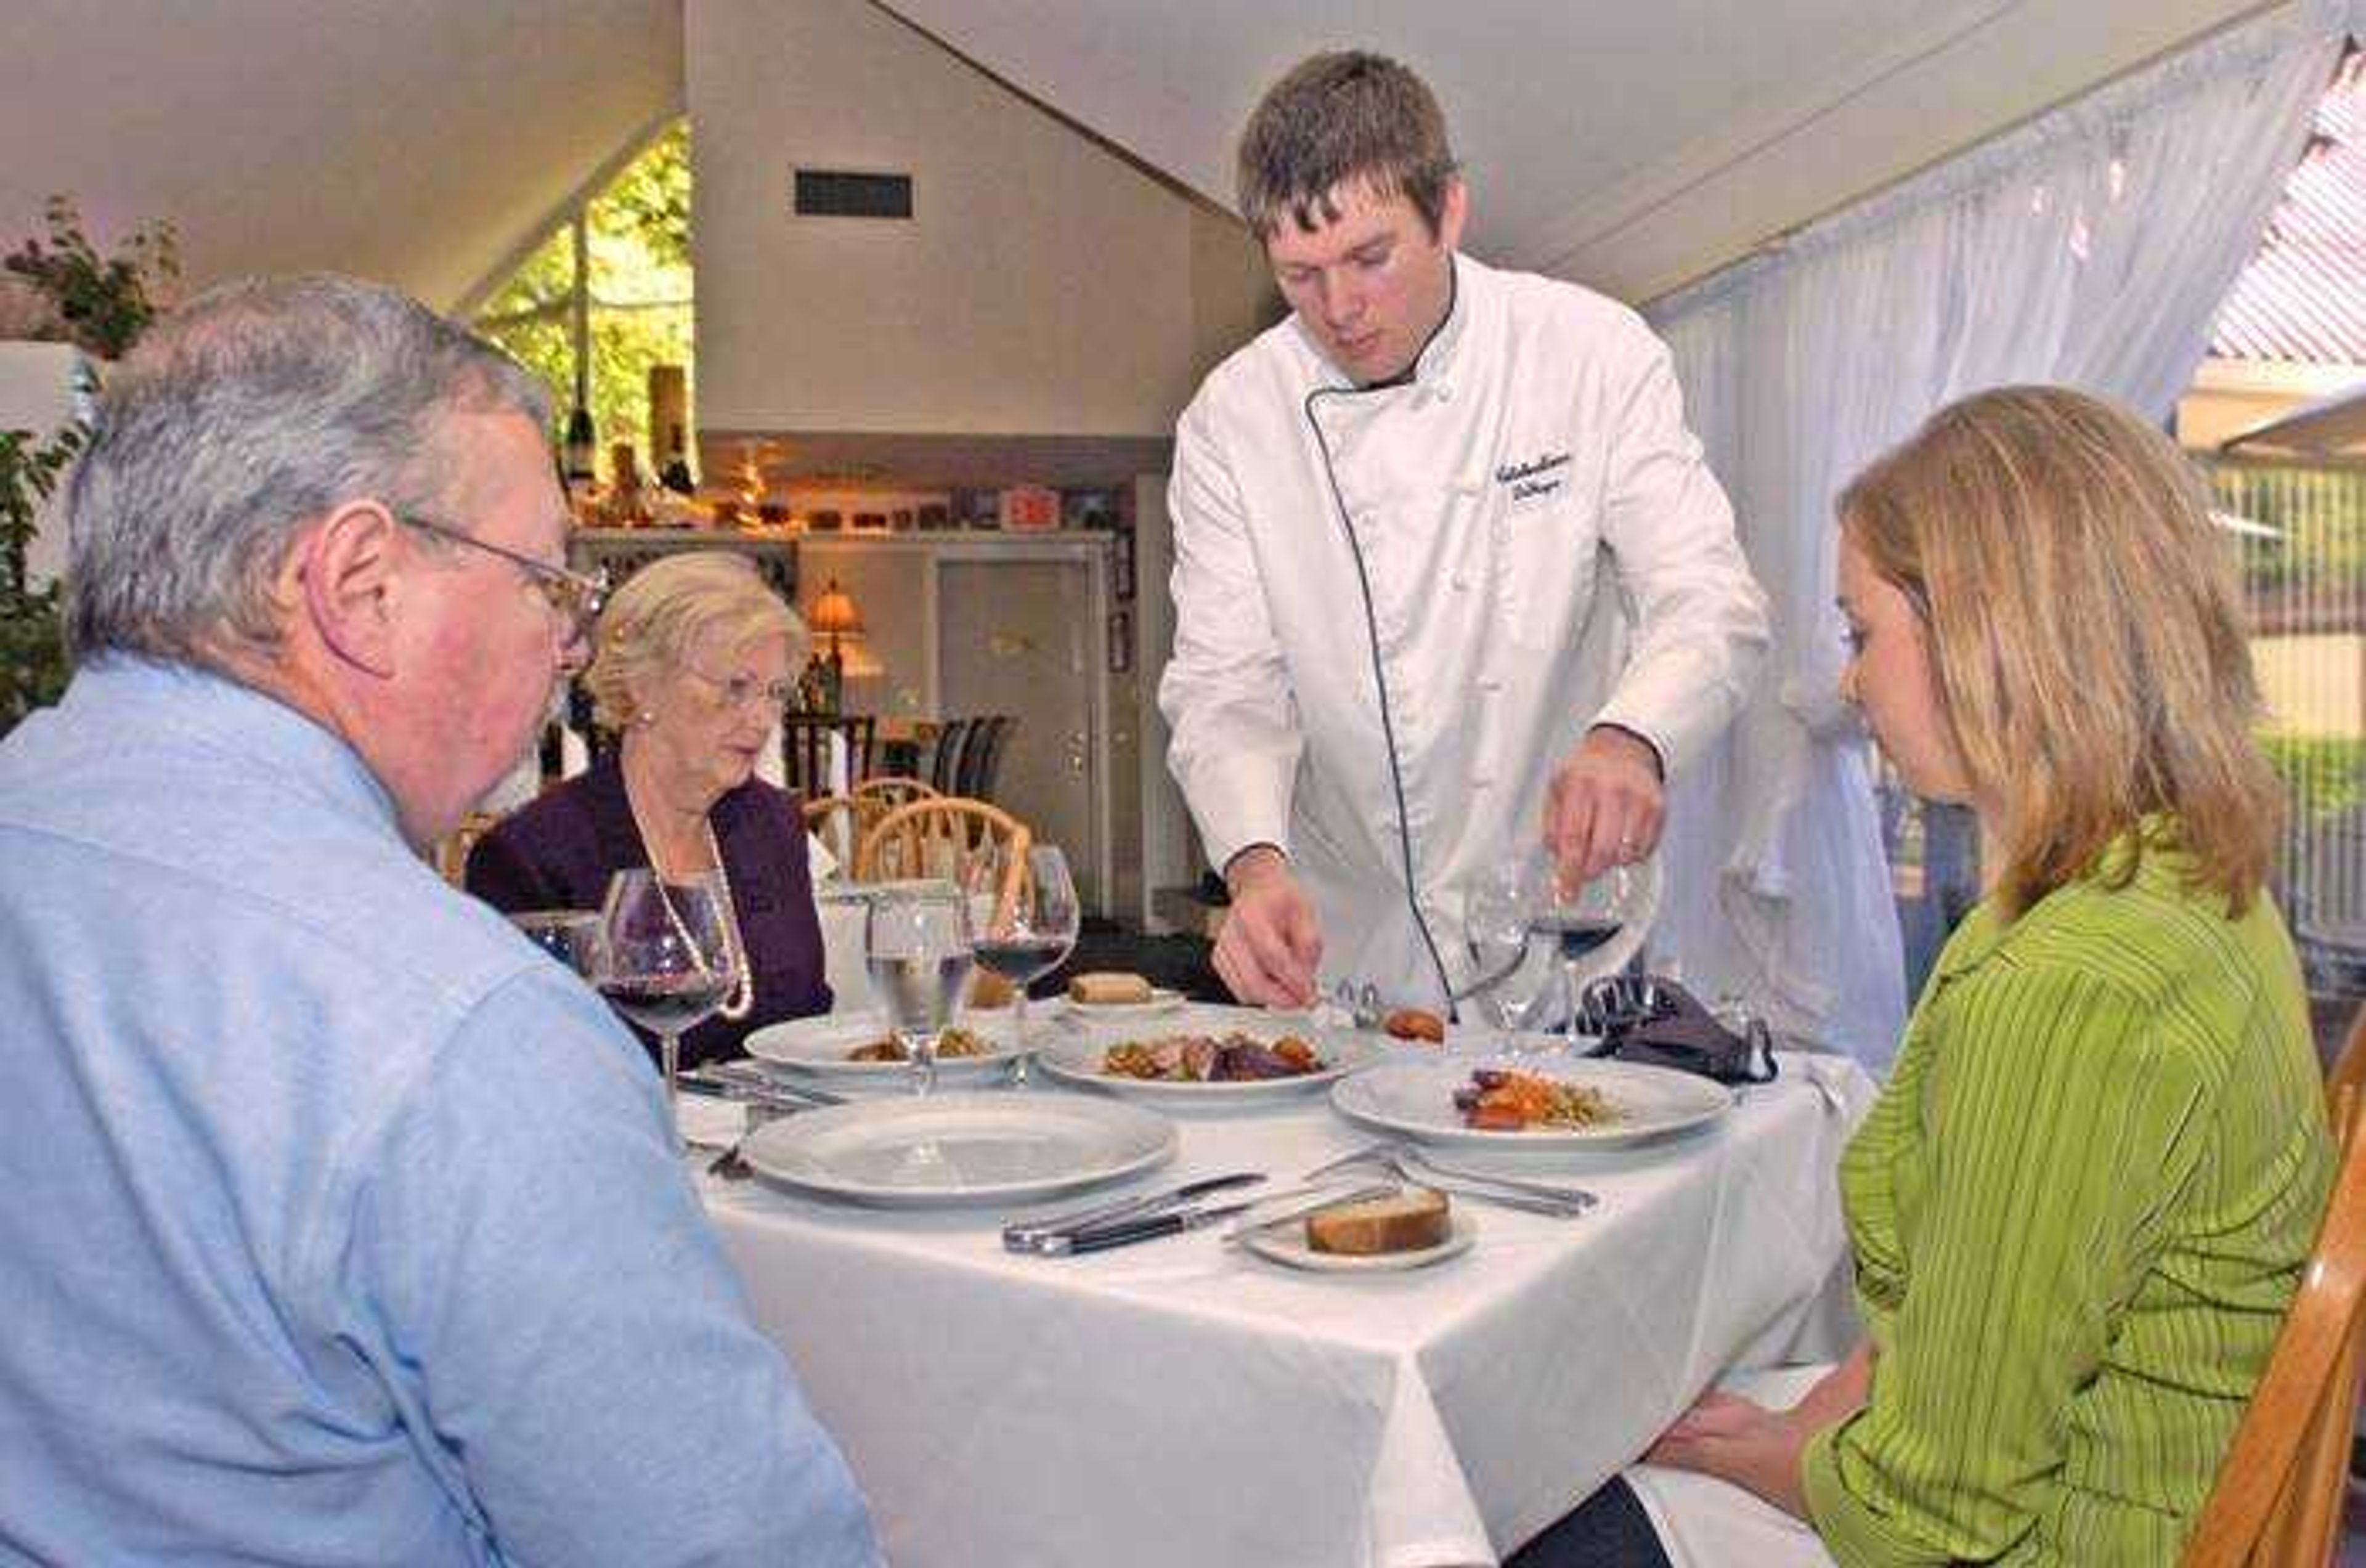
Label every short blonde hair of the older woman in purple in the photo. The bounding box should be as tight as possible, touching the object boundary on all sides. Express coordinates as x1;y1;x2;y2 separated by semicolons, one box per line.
584;551;814;731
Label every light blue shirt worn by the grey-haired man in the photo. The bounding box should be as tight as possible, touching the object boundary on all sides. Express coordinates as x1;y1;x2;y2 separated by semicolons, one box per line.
0;657;878;1568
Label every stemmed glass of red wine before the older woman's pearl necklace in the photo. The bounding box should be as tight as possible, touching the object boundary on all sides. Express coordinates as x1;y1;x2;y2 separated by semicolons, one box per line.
592;866;741;1105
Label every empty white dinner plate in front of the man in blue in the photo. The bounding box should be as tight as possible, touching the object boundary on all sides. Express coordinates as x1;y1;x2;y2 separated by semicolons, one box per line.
741;1095;1176;1209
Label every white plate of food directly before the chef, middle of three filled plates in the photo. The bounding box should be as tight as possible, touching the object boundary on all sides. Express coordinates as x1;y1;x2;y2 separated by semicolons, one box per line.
1036;1026;1380;1105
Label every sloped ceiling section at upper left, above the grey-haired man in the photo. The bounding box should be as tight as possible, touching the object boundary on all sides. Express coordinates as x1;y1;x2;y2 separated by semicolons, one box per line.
0;0;681;310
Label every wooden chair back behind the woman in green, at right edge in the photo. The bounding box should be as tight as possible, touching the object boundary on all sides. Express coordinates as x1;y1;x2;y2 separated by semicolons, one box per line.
2181;1050;2366;1568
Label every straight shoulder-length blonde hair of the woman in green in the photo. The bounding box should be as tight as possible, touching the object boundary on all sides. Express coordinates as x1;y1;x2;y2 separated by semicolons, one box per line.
1839;386;2283;916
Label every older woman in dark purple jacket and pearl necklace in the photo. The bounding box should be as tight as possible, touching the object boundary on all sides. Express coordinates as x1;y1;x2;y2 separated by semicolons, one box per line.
468;551;831;1066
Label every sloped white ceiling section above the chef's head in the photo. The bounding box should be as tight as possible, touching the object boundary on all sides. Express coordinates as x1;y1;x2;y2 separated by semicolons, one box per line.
885;0;2262;301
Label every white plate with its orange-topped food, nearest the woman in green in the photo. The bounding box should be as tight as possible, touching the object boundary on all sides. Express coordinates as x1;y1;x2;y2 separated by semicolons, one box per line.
1332;1060;1734;1154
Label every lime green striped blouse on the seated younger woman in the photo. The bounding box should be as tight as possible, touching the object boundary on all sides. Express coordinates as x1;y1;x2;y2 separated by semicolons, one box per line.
1805;827;2333;1568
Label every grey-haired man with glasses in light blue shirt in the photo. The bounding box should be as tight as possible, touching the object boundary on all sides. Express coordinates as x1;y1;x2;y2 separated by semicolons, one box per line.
0;277;878;1568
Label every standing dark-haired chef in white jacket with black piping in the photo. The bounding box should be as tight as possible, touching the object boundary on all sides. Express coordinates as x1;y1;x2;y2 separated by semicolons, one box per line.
1160;52;1767;1007
